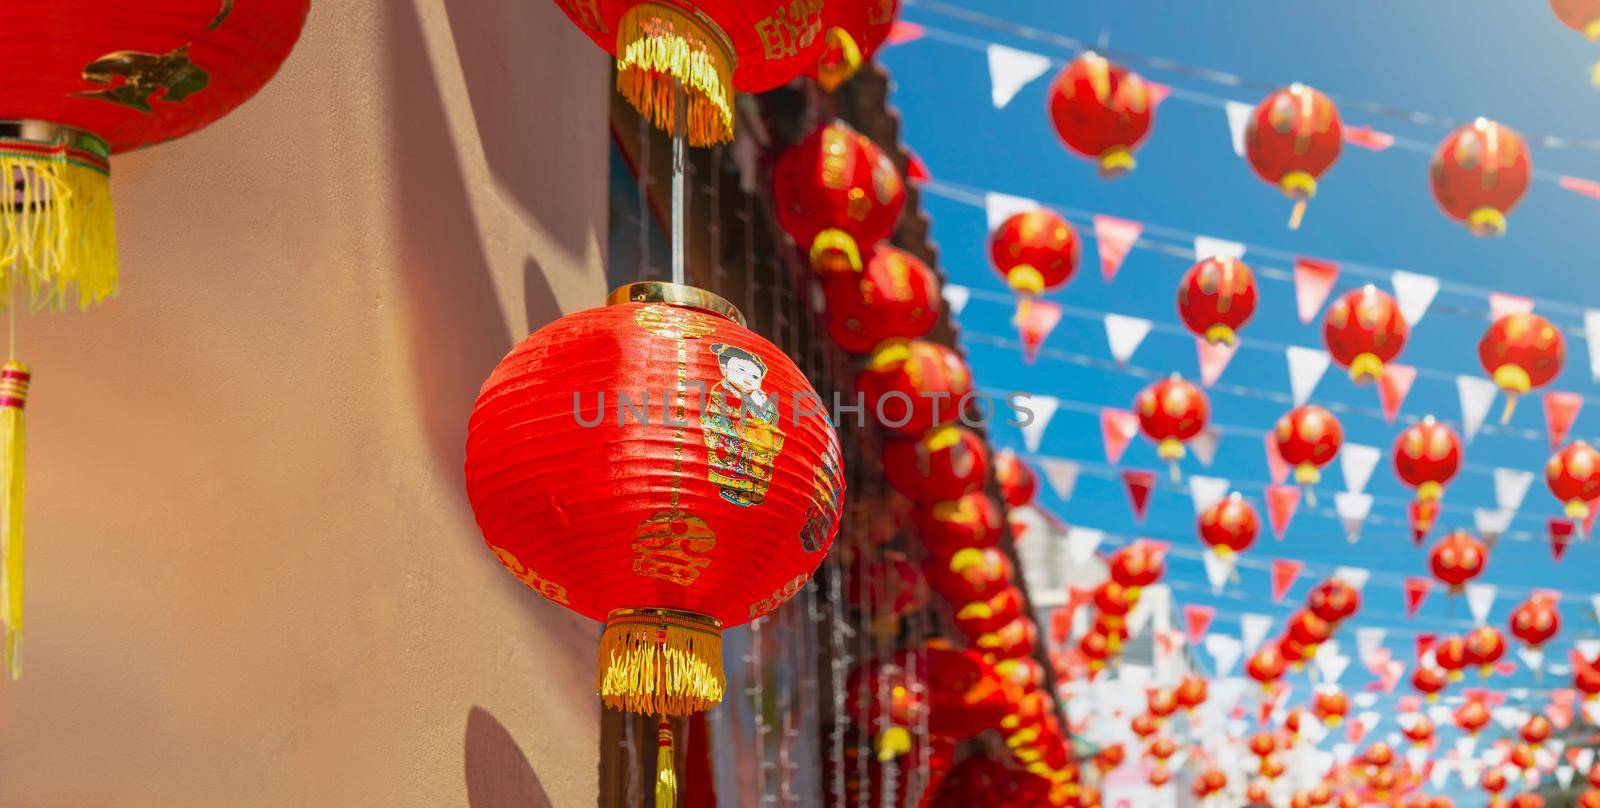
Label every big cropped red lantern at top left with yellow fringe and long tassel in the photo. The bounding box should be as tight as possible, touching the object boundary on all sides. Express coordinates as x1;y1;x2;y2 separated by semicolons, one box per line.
0;0;310;680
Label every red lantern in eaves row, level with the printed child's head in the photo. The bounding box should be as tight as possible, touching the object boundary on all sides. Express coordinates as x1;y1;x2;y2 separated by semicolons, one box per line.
856;339;973;441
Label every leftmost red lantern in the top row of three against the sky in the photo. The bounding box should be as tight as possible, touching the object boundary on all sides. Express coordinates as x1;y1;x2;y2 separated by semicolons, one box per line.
1050;51;1155;178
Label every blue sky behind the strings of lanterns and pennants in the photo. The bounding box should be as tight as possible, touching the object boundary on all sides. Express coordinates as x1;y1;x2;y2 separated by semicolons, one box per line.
880;0;1600;793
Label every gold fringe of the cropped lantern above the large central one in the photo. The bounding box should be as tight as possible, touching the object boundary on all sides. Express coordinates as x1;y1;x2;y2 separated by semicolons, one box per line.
616;3;734;146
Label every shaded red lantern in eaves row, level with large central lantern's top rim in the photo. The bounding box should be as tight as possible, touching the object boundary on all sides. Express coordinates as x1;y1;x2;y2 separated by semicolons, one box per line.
822;245;941;354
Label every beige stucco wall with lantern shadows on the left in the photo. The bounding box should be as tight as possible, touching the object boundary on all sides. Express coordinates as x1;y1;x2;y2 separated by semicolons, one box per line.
0;0;610;808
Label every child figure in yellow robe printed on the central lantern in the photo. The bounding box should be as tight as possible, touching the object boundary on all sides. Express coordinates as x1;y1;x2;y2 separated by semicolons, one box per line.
701;342;784;507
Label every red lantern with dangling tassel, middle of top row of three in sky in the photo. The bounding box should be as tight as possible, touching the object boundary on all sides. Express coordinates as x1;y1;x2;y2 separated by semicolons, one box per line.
1245;83;1344;229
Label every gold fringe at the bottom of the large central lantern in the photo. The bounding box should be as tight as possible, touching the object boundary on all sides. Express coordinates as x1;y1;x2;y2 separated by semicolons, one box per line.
595;610;726;717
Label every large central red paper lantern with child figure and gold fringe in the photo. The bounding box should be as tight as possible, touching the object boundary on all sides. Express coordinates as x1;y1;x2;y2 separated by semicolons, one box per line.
466;283;845;715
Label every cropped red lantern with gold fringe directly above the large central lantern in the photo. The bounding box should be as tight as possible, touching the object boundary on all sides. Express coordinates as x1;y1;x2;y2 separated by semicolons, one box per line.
555;0;822;146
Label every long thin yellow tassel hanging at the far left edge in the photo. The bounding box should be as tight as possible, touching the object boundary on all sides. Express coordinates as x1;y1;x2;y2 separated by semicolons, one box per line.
0;362;34;682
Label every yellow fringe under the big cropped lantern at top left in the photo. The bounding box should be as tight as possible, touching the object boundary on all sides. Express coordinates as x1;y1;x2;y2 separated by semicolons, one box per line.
0;138;117;309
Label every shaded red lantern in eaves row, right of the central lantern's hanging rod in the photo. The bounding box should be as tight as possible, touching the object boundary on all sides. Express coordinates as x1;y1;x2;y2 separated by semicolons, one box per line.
773;122;906;272
